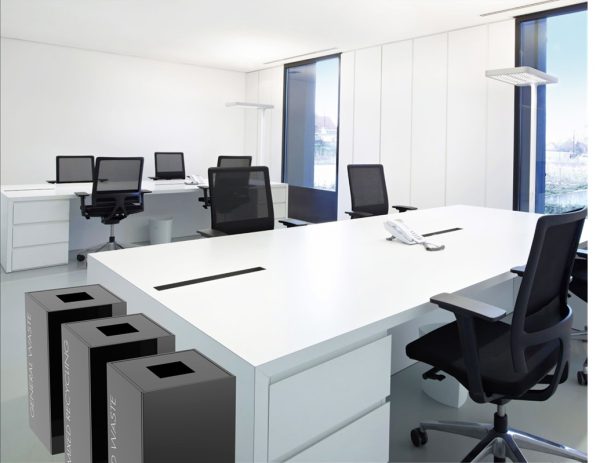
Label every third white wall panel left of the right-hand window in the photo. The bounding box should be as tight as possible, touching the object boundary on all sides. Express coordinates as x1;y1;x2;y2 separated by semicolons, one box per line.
411;34;448;208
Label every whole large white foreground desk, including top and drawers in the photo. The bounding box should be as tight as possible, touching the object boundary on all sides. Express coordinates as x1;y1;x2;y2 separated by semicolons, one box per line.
88;206;539;461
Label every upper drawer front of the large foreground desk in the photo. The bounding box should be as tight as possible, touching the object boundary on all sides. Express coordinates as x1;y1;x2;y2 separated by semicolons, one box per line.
269;336;391;460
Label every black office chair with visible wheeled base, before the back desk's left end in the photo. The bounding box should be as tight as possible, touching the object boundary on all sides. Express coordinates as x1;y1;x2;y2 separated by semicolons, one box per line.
75;157;150;262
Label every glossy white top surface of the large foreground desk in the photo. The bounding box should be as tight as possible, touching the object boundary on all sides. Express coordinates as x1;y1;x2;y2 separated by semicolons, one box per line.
89;206;539;366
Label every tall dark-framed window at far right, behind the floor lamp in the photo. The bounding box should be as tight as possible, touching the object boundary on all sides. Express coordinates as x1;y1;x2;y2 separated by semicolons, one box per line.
514;4;588;213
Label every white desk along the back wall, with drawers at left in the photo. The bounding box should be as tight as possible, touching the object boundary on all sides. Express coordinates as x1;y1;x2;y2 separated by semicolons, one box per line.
1;180;287;272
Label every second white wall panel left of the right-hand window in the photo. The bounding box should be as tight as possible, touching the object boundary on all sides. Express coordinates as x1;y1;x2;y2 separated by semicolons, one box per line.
446;26;488;206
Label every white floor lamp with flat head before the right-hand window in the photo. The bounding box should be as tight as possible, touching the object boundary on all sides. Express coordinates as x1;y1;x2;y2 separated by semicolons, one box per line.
485;66;558;212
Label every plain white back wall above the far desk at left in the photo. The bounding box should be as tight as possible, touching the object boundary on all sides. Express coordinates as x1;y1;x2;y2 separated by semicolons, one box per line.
1;39;246;184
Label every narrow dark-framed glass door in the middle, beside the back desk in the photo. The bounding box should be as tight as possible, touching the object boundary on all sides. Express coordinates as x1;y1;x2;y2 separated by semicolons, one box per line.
282;55;340;223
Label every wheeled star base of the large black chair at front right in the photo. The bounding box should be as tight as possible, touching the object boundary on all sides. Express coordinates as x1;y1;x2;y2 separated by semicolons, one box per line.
411;405;588;462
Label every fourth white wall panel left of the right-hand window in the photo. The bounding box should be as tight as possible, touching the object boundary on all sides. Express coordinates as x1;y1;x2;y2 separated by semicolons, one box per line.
381;41;412;205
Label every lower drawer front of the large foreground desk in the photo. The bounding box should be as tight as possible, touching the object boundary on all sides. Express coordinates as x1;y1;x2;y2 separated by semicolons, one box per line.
287;403;390;463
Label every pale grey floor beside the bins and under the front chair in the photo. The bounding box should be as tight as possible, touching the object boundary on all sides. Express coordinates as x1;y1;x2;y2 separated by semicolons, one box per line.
0;262;588;463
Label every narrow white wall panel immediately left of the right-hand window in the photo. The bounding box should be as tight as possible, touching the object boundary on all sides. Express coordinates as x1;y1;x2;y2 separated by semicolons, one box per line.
485;20;515;209
